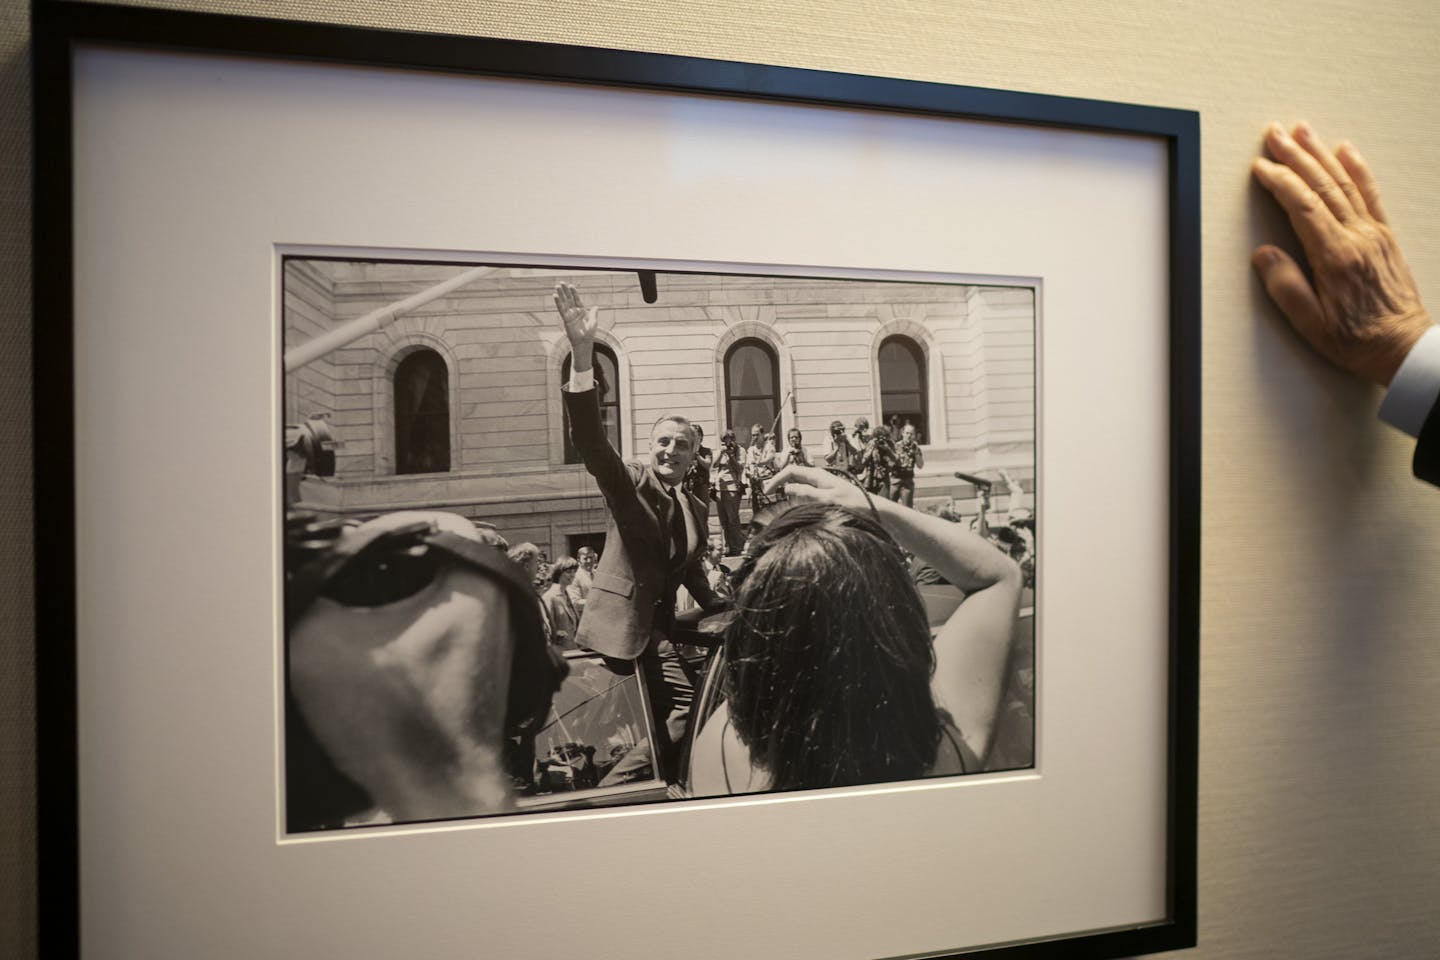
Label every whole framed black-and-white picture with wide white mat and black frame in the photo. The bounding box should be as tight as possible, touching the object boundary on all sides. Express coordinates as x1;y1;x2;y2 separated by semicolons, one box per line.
36;3;1200;959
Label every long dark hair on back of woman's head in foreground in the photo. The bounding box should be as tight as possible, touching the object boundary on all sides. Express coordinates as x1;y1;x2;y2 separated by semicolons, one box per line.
724;504;940;790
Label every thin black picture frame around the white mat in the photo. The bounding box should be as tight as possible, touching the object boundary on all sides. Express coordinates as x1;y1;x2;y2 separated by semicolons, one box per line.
33;0;1201;960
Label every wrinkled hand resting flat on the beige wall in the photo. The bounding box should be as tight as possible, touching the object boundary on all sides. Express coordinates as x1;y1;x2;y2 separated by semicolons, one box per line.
1250;122;1431;386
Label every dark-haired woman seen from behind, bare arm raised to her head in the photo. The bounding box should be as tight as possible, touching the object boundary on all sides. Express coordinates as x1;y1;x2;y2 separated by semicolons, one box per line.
691;466;1020;796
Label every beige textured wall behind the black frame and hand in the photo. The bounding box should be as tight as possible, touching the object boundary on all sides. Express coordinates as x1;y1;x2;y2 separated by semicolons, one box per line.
8;0;1440;960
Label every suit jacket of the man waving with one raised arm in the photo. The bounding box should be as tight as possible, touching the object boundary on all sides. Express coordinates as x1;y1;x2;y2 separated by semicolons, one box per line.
560;389;716;661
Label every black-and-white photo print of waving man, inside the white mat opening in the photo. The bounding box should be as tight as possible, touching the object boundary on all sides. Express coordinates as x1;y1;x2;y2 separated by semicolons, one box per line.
281;253;1038;832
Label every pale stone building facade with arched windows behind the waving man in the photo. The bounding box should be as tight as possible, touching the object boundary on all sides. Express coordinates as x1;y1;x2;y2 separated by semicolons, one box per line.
284;259;1037;556
